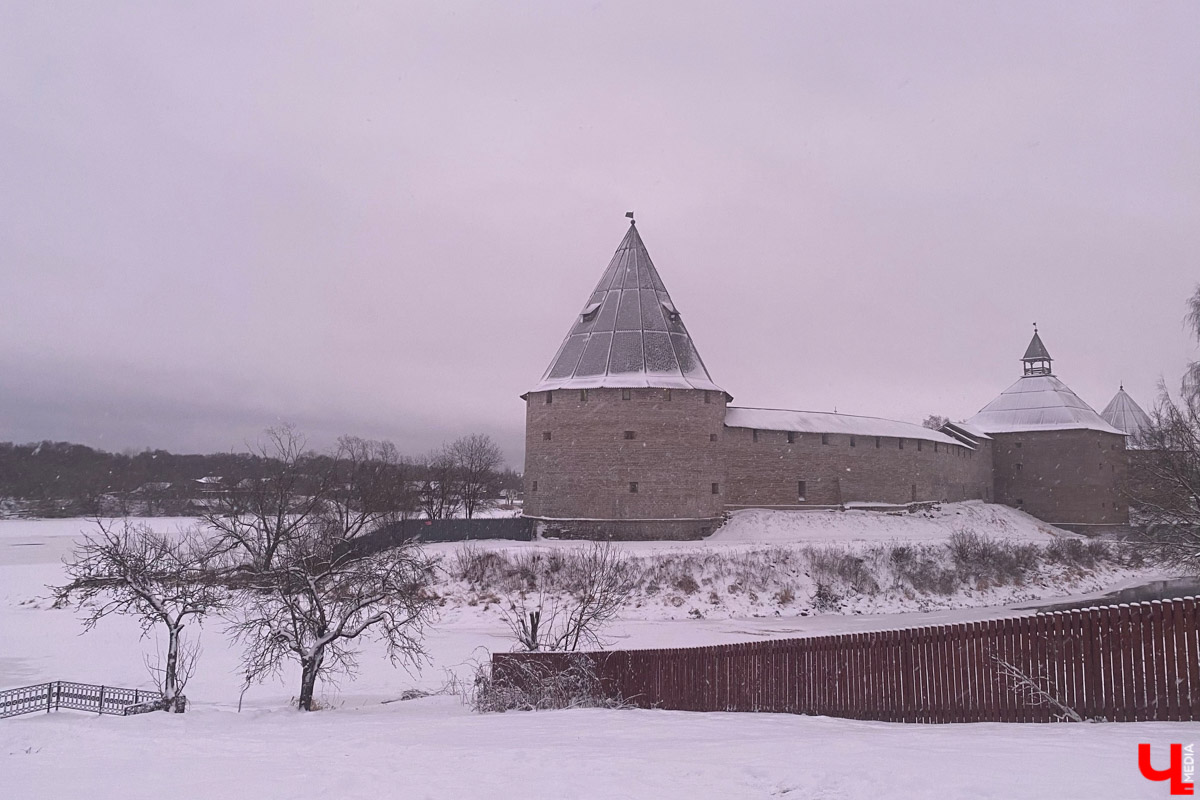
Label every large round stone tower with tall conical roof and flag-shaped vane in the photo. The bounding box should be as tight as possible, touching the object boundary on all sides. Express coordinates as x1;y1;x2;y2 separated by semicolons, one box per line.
522;221;731;539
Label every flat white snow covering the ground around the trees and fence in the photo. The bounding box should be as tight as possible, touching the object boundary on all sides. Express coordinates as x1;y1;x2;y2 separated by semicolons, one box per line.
0;513;1200;800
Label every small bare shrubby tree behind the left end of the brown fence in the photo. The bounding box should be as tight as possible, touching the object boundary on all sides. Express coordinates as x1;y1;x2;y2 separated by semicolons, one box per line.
505;542;637;652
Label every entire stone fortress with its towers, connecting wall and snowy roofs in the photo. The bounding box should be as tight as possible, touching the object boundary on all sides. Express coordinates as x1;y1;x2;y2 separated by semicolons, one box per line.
522;222;1145;539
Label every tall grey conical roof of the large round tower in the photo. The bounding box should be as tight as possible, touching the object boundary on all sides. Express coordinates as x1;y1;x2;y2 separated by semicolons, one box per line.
533;223;724;392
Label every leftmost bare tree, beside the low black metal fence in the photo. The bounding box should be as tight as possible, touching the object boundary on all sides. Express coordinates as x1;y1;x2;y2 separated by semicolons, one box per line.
54;519;224;711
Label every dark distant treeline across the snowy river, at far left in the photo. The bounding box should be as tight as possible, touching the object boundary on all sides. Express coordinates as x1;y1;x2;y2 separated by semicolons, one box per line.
0;441;521;517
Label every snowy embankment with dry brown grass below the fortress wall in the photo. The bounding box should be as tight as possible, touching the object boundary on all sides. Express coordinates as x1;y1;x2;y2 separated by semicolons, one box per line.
431;503;1161;620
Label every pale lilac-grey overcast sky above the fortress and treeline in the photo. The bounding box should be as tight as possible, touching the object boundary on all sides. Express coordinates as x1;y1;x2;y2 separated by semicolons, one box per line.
0;0;1200;467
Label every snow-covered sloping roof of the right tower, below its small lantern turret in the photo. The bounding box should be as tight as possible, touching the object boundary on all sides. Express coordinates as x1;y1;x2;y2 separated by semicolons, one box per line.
966;375;1123;434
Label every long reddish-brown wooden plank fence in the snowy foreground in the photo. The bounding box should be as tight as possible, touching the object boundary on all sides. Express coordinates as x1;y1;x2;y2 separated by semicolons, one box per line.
492;597;1200;722
